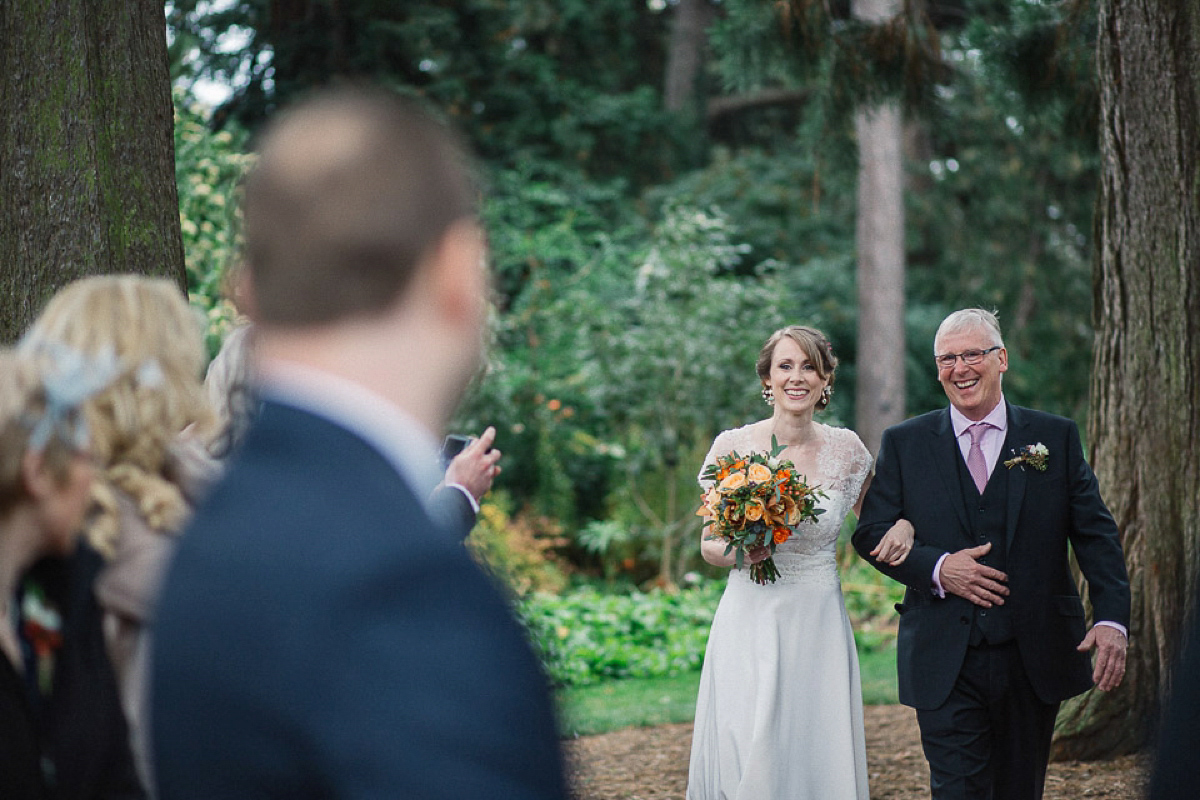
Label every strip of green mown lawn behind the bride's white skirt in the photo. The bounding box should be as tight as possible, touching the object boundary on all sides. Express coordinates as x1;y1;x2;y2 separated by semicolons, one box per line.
558;646;896;736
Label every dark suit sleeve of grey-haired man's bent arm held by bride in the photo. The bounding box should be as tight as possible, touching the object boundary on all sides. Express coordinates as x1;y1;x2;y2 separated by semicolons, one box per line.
851;428;946;594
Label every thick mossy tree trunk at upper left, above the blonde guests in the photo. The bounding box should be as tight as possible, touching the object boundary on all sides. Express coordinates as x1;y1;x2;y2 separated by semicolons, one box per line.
0;0;185;342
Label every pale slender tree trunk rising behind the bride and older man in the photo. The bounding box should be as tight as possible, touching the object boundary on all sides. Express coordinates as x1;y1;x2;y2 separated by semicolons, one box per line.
852;0;906;453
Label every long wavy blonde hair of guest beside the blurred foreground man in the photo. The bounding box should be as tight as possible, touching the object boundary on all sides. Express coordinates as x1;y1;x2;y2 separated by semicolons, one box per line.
25;275;212;555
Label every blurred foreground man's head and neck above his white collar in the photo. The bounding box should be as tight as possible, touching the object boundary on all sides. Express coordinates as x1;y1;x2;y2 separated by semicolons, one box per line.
238;90;487;431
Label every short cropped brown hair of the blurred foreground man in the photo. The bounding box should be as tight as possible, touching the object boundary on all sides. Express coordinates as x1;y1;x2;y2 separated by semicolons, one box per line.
245;90;476;327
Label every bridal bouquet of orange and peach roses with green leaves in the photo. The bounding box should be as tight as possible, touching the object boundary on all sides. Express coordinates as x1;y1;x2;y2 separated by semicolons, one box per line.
696;437;824;584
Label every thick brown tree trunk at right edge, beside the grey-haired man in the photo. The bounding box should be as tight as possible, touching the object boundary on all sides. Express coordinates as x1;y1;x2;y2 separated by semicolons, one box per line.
1055;0;1200;758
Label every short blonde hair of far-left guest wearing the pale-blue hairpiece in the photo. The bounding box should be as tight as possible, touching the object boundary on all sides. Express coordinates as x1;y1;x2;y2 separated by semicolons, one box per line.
0;348;81;518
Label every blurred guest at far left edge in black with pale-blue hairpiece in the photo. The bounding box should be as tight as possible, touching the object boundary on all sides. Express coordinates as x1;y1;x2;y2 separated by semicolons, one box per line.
0;350;144;800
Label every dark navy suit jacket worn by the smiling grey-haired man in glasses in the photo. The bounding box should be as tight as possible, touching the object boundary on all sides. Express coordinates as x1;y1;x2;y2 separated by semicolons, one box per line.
853;405;1129;710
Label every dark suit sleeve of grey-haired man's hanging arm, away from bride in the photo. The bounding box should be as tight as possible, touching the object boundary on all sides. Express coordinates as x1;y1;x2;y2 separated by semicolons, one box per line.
1067;422;1130;628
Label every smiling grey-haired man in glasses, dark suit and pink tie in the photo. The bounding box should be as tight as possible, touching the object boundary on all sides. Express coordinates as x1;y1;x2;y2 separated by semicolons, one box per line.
853;308;1129;800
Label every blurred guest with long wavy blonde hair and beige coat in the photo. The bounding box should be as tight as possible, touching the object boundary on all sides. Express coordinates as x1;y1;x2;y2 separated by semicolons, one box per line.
23;275;216;786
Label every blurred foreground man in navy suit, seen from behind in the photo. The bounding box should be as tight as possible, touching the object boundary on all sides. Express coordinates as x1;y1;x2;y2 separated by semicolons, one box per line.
151;91;566;800
